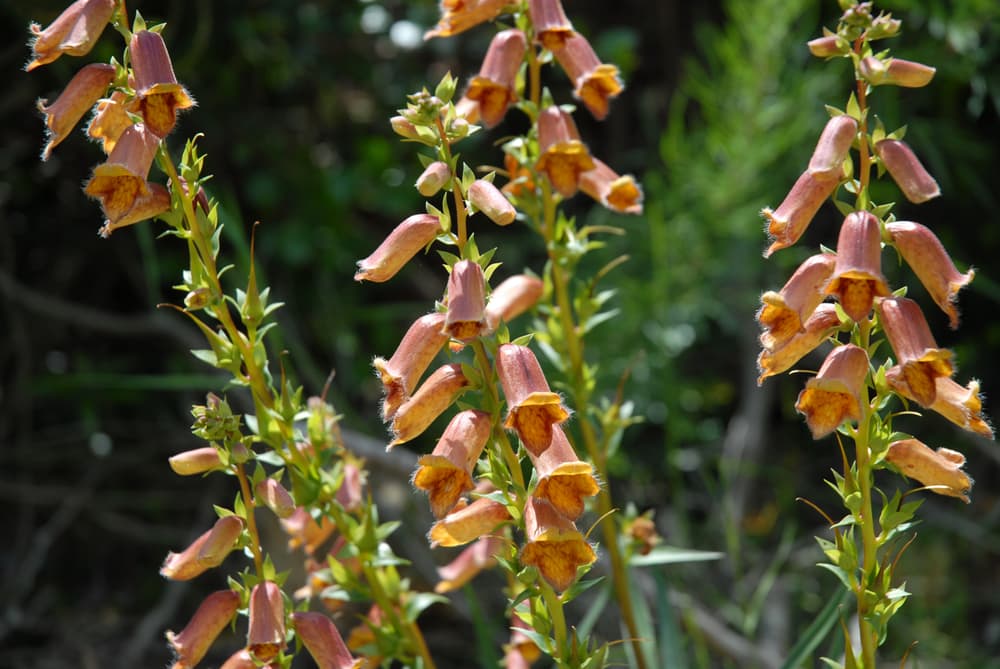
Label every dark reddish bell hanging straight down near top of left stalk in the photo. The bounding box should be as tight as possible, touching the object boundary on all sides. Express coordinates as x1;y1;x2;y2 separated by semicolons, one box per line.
129;30;194;137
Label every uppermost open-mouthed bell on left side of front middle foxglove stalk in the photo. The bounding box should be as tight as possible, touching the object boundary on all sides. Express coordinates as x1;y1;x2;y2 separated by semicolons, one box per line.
372;313;448;421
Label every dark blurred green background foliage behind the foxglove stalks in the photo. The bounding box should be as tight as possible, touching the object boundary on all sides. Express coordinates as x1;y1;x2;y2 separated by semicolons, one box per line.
0;0;1000;668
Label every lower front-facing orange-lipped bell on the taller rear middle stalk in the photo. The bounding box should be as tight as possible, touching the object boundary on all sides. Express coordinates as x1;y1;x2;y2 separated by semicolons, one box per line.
535;106;597;197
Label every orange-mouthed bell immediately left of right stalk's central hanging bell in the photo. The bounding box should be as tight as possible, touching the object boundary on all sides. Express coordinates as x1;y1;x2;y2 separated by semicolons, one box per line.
757;253;837;350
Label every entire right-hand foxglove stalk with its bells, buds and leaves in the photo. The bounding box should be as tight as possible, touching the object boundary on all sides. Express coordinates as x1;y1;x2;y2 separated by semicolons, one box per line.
757;0;993;669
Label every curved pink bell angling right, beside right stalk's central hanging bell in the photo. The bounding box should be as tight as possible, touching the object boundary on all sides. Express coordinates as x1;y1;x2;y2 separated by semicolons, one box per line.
885;221;976;329
